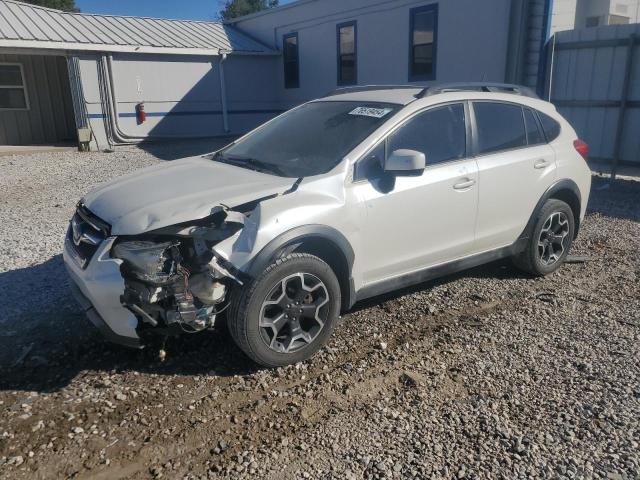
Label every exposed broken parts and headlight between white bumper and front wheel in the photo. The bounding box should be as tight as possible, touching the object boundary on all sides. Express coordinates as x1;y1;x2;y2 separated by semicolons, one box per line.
111;207;246;341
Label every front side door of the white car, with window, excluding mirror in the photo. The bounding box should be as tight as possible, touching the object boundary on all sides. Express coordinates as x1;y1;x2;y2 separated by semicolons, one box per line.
354;103;478;285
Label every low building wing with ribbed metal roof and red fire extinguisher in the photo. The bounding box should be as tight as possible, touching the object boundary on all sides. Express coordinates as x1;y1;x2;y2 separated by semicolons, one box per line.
0;0;279;149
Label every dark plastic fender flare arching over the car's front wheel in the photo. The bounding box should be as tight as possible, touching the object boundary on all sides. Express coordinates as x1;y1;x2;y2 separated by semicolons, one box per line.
247;224;356;309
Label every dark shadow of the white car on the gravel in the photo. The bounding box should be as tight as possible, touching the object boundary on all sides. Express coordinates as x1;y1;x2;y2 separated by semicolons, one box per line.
0;255;520;393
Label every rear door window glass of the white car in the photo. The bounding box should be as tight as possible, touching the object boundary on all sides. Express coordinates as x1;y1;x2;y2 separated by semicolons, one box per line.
473;102;527;154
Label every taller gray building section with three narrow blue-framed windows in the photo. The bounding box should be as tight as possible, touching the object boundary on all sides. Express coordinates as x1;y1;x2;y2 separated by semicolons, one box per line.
230;0;551;108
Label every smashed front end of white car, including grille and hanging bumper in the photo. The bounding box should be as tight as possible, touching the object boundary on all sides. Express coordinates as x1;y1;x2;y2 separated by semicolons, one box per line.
63;205;250;348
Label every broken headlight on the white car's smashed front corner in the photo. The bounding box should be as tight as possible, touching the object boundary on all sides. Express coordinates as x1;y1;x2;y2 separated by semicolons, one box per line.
111;240;179;283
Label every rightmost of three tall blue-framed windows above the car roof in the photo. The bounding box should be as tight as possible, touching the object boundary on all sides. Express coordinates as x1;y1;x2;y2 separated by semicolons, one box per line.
409;4;438;81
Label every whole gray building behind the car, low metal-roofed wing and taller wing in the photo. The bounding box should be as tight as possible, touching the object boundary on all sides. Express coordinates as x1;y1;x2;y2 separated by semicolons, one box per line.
0;0;552;148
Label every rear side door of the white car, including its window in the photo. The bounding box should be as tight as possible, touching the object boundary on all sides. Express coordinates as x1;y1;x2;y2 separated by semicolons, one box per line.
472;101;556;252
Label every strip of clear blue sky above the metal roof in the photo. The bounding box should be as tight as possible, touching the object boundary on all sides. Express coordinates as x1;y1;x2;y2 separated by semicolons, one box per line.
76;0;291;20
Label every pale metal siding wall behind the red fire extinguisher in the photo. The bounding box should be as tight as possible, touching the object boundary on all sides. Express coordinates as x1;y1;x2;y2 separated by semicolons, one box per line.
78;54;279;149
